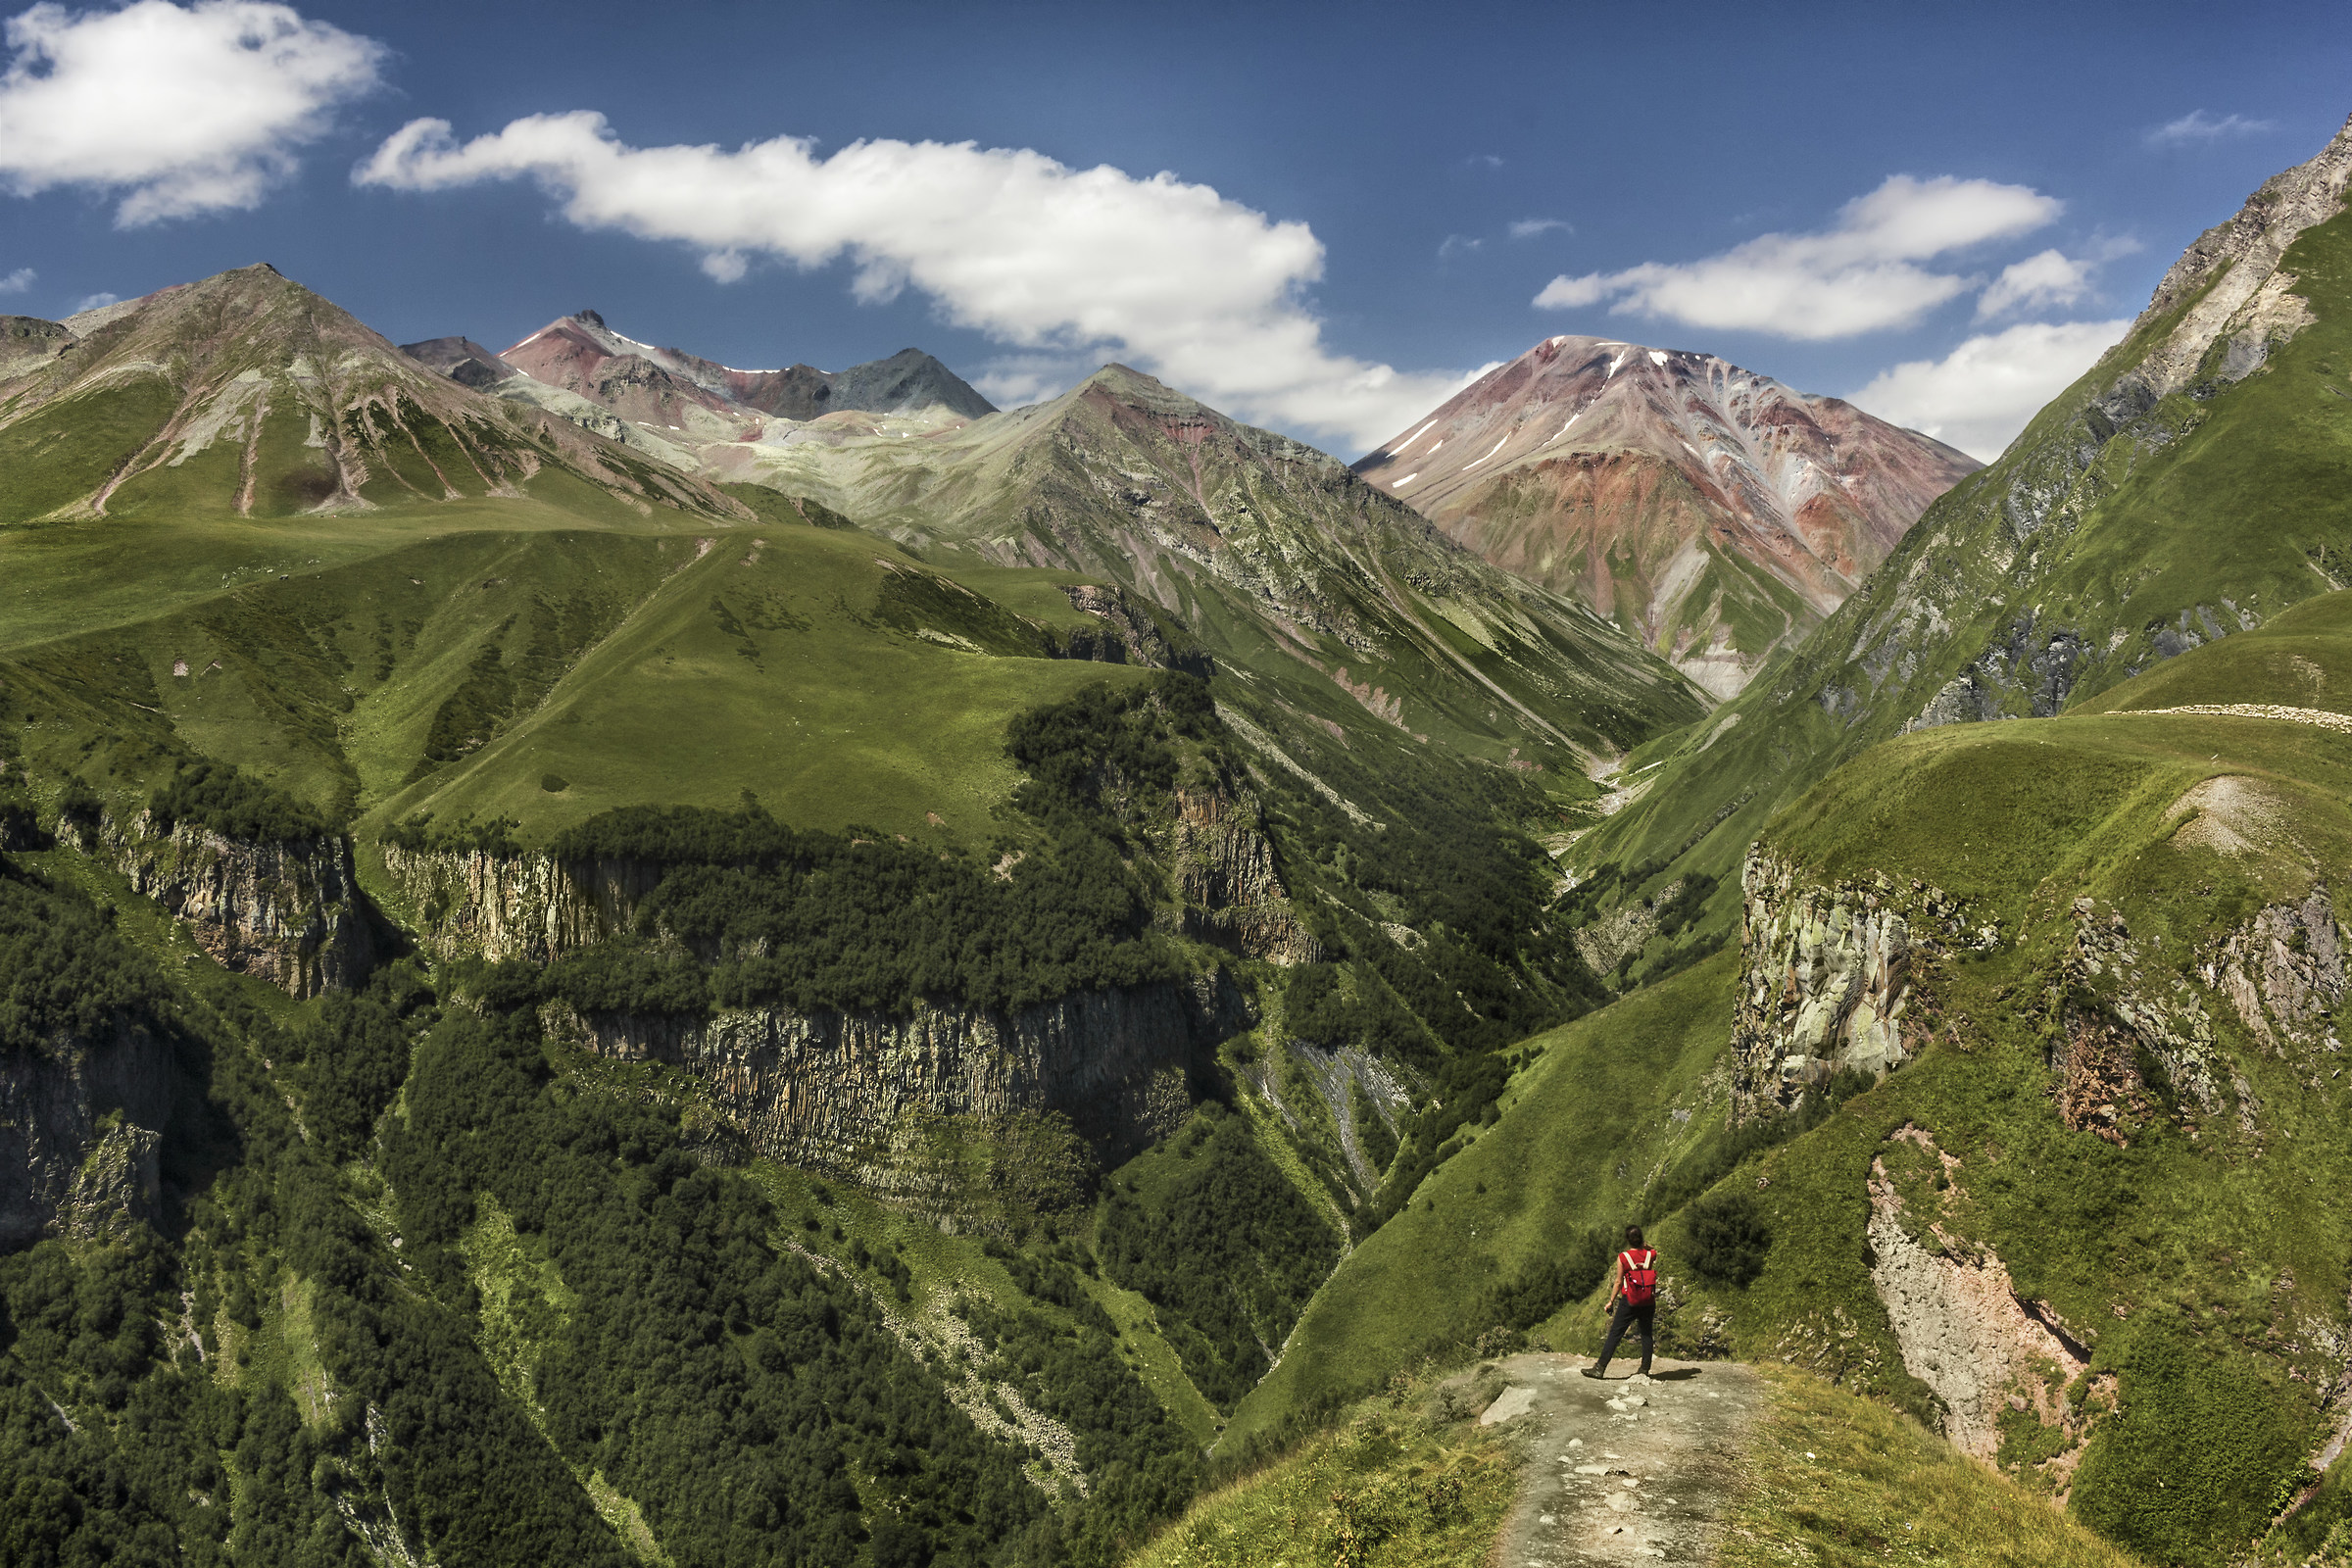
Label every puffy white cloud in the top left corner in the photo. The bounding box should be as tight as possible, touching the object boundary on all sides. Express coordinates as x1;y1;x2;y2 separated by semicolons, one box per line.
0;0;383;228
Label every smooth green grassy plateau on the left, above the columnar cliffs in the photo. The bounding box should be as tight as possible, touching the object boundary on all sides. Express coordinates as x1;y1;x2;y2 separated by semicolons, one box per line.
0;503;1143;835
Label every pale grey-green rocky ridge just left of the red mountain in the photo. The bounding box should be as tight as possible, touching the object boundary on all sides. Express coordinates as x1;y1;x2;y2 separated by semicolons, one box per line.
706;367;1703;797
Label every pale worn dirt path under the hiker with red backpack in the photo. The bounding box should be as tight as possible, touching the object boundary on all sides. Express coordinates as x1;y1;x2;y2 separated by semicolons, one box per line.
1448;1354;1764;1568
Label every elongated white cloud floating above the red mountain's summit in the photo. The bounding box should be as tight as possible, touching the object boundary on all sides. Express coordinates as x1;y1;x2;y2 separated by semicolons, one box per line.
1536;174;2063;341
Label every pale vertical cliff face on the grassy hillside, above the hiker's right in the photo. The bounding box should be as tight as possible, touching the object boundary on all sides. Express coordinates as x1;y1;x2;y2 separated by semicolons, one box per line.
1731;844;1999;1121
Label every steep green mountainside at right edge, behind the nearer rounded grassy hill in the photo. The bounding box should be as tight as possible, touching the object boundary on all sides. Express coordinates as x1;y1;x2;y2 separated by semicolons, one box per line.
1571;166;2352;978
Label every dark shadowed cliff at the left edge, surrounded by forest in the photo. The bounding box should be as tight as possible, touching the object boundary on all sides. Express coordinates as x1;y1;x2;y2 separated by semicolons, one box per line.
0;1022;174;1250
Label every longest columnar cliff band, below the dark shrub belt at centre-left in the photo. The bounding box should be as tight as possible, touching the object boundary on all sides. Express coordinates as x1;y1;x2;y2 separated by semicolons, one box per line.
548;971;1253;1195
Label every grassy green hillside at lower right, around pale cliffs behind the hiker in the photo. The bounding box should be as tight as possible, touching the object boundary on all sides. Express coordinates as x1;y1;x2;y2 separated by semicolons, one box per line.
1235;595;2352;1563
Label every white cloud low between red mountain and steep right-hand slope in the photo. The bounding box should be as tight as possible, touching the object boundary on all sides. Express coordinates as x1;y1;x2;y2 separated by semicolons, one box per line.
1851;319;2131;464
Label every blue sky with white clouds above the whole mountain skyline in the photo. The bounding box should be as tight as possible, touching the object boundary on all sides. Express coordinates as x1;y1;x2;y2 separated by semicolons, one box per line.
0;0;2352;459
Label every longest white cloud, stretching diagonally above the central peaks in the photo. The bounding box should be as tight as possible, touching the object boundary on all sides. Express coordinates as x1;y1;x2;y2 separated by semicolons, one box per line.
353;111;1468;449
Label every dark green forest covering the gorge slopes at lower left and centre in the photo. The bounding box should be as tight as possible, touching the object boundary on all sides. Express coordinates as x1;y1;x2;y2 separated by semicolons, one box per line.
0;672;1594;1568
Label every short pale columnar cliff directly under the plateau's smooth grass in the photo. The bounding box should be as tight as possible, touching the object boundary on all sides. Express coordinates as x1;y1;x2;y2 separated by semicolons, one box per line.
383;842;665;964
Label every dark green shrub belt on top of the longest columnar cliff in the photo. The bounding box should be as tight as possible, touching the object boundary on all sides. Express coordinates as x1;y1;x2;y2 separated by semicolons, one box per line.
533;674;1213;1013
